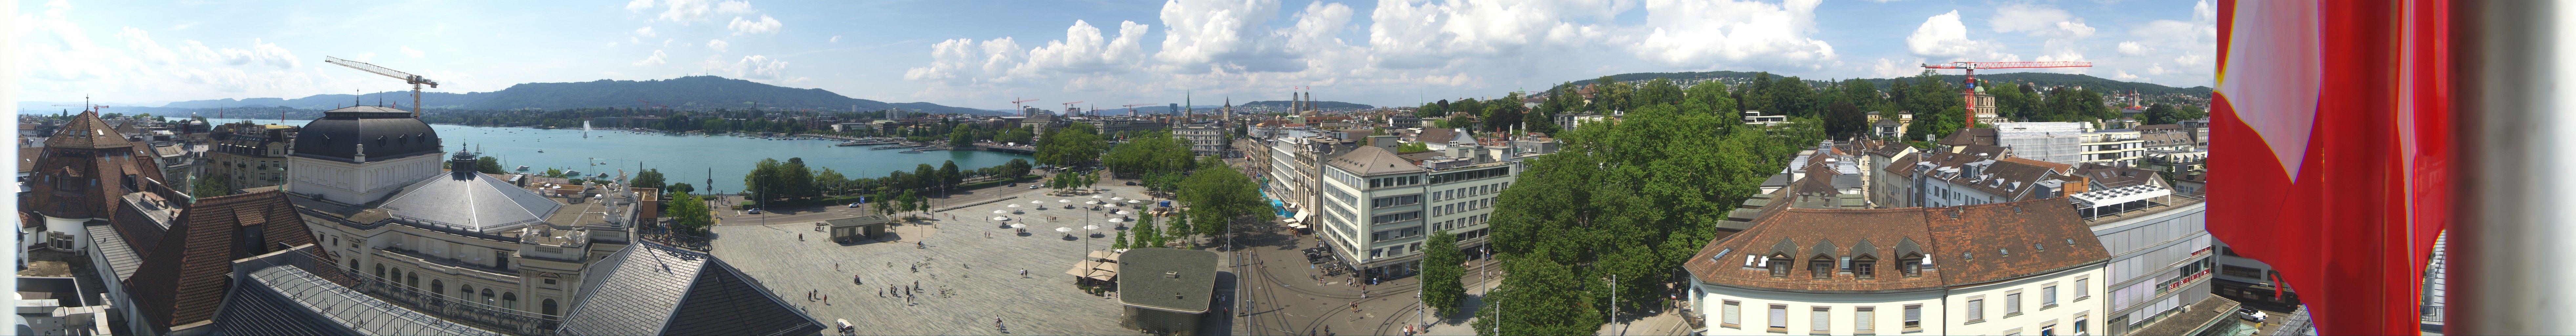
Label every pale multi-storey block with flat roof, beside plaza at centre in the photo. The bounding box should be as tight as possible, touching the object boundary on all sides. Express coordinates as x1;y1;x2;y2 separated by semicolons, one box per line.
1311;135;1517;279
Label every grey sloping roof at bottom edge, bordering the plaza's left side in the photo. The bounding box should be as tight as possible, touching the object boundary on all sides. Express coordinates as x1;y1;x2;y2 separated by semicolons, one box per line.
556;241;824;336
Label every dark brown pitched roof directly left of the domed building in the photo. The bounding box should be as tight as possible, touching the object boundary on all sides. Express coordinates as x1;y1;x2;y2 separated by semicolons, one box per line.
126;191;330;331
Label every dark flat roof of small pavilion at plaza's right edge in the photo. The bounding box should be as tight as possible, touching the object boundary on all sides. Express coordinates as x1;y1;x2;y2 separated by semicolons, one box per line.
1118;248;1216;313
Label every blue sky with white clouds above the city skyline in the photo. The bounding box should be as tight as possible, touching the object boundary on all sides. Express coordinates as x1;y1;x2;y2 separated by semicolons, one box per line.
15;0;2218;109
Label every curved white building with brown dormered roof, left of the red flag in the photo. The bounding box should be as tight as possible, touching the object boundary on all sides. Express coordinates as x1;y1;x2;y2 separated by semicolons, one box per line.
1682;199;2110;336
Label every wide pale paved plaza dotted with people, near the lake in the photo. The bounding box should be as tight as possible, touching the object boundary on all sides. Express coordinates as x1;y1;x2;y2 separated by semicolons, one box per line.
714;186;1231;336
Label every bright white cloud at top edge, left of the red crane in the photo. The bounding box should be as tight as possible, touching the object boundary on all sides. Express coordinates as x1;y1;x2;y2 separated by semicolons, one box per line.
1631;0;1834;67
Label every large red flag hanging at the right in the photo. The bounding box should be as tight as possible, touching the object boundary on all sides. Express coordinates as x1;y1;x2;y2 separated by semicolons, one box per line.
2208;0;2452;336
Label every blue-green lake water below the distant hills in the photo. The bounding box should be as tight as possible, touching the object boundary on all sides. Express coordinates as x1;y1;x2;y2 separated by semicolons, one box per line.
206;119;1028;194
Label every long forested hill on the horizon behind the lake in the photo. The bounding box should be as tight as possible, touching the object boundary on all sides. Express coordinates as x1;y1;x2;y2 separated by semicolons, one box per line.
143;75;999;114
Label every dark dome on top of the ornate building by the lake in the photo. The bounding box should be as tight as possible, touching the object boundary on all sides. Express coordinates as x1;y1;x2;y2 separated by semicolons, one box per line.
294;106;438;163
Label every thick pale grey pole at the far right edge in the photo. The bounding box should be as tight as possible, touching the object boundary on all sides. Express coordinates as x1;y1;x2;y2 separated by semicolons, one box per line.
2442;3;2576;336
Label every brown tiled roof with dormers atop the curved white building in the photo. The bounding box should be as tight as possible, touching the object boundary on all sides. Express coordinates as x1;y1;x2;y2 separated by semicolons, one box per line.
1682;199;2110;292
